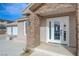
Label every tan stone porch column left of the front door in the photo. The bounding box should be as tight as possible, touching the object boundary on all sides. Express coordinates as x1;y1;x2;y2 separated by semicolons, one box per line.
27;13;40;48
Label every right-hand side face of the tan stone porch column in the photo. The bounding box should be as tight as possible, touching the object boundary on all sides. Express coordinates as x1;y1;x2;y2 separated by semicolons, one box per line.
34;15;40;47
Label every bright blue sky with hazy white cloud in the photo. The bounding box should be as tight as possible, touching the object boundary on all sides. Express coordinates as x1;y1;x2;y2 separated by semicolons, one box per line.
0;3;27;21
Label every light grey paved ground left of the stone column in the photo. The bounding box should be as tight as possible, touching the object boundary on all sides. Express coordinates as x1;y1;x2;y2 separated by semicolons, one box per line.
0;39;25;56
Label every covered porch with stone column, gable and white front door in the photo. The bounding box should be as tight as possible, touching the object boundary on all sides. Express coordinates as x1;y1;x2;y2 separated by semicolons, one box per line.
25;3;77;56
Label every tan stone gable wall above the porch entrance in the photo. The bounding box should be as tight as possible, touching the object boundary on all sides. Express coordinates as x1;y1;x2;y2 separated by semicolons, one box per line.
35;3;76;16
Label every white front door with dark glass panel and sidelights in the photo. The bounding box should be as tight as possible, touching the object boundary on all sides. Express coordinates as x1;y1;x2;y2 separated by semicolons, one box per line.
47;16;69;44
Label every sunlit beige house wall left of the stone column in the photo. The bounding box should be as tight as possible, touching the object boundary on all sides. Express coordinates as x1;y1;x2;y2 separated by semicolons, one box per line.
6;21;27;43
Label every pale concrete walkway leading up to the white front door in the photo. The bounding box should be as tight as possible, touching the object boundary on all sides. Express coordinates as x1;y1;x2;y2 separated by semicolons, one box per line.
31;43;75;56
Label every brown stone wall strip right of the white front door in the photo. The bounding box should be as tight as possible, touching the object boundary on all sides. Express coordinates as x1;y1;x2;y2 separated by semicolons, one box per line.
69;13;77;47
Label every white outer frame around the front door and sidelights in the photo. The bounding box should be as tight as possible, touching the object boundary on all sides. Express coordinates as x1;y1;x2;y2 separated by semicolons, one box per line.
46;16;69;46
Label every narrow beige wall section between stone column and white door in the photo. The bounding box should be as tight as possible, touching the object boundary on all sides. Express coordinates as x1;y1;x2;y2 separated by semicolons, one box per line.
40;18;46;42
